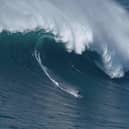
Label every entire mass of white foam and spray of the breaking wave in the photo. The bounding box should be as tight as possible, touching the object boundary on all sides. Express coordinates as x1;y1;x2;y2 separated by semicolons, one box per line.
0;0;129;78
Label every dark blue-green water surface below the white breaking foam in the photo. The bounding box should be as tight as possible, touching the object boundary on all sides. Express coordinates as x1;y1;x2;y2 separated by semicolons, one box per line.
0;0;129;129
